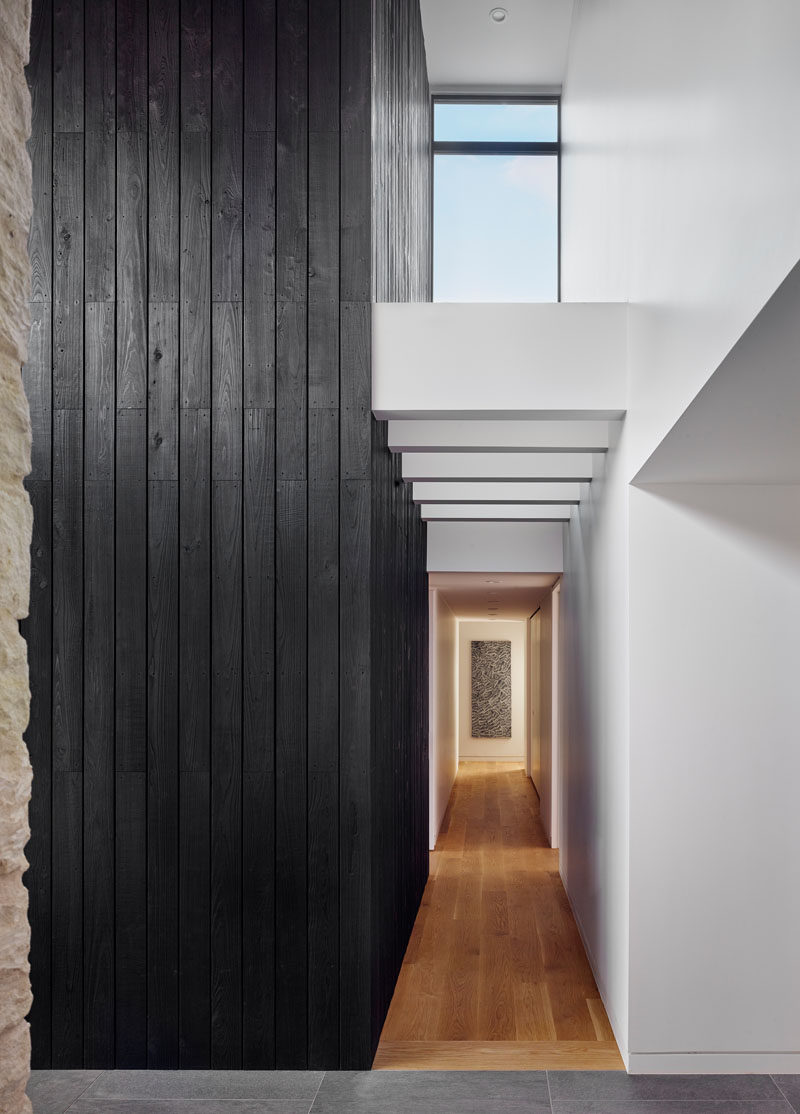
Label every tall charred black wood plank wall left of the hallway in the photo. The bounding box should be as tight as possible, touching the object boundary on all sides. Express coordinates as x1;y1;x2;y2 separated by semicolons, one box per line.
25;0;429;1067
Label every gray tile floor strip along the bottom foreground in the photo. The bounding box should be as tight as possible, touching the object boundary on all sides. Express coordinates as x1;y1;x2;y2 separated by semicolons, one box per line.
28;1072;800;1114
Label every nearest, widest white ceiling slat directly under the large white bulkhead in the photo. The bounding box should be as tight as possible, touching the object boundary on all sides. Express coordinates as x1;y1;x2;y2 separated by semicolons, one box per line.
389;419;608;453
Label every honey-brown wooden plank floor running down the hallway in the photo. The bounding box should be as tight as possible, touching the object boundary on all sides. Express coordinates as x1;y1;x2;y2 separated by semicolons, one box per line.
373;762;623;1069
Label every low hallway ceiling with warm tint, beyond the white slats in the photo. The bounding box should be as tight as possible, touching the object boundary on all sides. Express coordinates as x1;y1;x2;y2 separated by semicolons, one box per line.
428;573;558;619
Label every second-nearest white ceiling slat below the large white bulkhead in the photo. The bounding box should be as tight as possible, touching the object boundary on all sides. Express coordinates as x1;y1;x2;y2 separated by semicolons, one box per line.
402;452;592;483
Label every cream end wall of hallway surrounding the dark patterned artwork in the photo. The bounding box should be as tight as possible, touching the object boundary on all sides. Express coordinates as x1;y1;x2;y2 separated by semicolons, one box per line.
458;619;527;762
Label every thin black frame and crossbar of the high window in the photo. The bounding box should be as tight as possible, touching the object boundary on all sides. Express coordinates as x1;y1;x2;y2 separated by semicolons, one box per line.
430;94;562;302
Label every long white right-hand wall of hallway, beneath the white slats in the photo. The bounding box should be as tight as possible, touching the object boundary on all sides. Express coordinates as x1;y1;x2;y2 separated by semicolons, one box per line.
559;421;628;1058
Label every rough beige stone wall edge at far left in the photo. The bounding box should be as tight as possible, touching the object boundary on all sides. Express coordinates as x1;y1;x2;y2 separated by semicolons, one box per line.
0;0;32;1114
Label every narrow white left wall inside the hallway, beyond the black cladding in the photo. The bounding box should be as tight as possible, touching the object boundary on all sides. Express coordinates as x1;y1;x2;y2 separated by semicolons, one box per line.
428;588;458;850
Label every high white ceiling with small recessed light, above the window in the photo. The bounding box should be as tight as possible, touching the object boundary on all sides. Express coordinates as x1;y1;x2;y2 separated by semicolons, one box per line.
420;0;573;92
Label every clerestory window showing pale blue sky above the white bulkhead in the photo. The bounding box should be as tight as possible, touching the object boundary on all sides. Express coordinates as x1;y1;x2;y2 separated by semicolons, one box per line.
433;97;559;302
